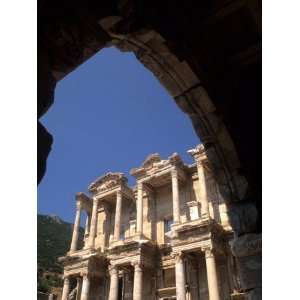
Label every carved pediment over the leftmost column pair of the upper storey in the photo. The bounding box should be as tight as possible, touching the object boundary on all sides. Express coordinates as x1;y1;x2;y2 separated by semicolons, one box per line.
89;172;128;192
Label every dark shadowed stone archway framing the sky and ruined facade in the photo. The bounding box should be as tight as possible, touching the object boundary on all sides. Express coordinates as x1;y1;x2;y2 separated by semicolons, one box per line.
38;1;261;298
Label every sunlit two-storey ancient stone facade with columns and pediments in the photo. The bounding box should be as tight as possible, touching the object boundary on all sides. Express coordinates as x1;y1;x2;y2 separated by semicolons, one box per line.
61;145;251;300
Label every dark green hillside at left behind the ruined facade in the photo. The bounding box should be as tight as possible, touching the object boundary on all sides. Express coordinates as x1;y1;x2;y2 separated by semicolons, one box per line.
37;215;84;292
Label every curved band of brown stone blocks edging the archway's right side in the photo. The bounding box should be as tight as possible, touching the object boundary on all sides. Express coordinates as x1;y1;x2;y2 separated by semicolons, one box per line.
99;25;251;231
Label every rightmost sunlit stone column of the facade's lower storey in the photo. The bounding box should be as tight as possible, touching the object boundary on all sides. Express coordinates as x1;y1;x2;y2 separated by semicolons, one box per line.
205;249;221;300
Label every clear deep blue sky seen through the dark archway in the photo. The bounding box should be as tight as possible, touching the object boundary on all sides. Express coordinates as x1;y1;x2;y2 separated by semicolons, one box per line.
38;48;199;222
